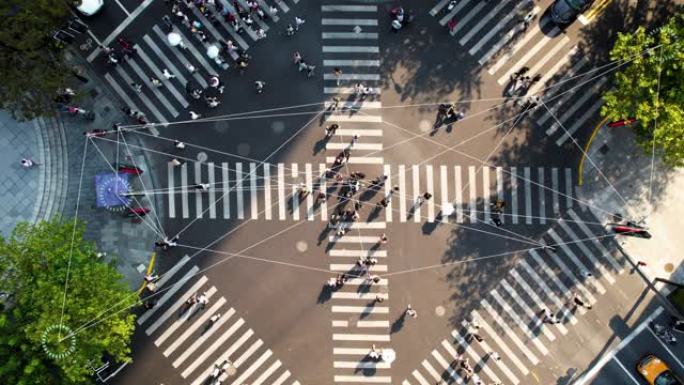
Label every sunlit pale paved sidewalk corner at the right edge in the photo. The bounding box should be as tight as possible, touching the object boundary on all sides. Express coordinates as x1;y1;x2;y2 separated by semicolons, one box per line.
577;121;684;287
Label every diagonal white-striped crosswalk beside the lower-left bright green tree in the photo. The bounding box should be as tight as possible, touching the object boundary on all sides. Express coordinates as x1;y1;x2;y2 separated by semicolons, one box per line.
137;255;300;385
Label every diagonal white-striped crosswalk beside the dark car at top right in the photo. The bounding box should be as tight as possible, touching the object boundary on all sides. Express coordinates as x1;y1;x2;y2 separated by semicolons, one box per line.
429;0;612;147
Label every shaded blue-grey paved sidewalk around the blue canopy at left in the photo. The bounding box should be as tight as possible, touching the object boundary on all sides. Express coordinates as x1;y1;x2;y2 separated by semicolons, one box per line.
0;52;163;289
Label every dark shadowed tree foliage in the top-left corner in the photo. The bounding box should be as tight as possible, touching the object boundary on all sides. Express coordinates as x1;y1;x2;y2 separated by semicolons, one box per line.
0;0;69;119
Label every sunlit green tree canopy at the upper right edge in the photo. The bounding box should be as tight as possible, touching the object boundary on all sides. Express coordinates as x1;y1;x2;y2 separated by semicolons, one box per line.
601;14;684;166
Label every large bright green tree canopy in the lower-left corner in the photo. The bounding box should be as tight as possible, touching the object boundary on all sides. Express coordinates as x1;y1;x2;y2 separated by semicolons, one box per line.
0;220;136;385
